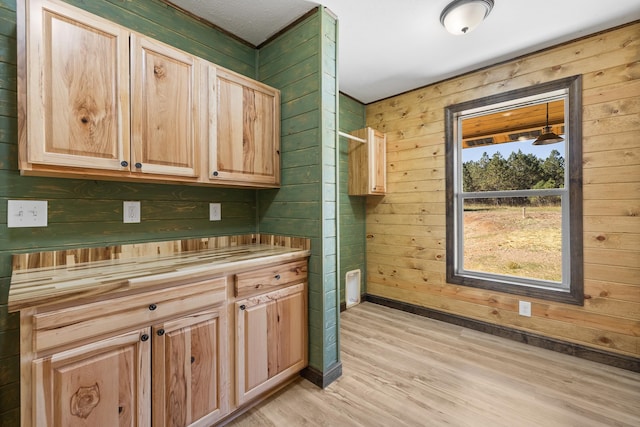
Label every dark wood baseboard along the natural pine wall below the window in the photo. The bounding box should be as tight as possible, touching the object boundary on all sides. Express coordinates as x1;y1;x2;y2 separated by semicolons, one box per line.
365;294;640;372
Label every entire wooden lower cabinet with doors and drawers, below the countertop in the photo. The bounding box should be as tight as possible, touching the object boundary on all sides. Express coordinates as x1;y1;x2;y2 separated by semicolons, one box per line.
20;259;308;427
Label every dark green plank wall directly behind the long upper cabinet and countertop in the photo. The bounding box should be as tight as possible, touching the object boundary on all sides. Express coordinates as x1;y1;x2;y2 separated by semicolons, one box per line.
0;0;257;427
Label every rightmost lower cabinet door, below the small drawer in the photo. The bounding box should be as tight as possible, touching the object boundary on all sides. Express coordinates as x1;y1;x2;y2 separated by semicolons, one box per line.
236;283;307;405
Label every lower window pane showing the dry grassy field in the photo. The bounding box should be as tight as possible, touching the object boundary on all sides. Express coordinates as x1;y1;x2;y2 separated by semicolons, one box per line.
462;196;562;282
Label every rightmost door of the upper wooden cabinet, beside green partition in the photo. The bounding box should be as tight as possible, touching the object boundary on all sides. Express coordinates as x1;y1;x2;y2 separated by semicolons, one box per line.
209;67;280;187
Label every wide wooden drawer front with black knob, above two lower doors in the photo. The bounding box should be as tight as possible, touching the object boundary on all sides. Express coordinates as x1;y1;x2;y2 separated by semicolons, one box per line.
33;277;227;352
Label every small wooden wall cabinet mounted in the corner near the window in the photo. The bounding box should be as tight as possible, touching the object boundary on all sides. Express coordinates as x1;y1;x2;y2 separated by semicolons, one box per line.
348;127;387;196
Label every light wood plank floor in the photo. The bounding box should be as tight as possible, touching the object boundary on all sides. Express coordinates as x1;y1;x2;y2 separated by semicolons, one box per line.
229;303;640;427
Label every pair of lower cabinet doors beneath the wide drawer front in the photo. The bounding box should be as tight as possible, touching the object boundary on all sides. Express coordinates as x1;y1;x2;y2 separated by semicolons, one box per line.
33;307;229;427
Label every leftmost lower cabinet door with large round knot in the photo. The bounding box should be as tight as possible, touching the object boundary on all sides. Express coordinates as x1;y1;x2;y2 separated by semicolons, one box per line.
32;328;151;427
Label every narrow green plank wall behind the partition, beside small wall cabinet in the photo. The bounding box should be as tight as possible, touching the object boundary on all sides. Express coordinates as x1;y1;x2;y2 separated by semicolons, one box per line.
338;94;367;303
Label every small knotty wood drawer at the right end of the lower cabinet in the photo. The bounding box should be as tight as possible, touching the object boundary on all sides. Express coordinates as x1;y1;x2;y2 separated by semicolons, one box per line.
235;260;307;297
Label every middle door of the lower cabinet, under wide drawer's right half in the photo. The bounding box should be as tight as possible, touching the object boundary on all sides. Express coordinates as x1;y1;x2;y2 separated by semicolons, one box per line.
153;308;228;427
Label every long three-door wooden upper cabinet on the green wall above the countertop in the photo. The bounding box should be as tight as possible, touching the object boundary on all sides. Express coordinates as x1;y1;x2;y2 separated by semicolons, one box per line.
18;0;280;187
